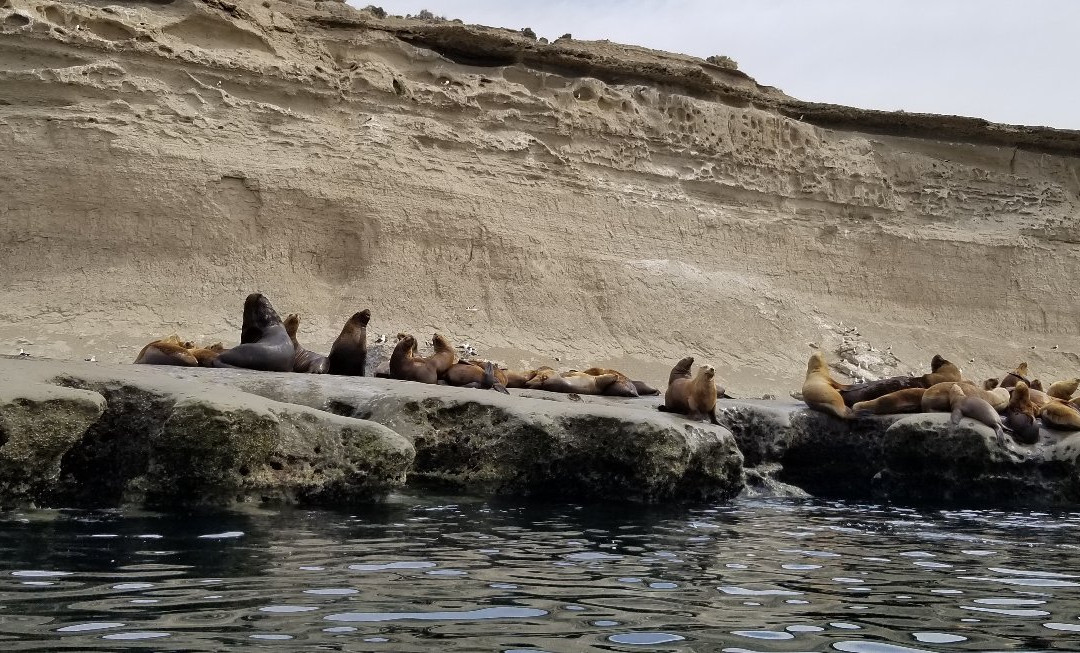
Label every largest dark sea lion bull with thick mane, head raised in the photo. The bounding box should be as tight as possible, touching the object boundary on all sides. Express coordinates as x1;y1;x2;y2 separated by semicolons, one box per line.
213;293;296;372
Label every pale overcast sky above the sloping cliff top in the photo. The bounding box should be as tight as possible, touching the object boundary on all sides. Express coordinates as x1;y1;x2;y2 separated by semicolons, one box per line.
349;0;1080;130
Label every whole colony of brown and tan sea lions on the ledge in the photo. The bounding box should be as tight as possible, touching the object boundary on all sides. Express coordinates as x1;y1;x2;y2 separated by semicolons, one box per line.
135;293;1080;436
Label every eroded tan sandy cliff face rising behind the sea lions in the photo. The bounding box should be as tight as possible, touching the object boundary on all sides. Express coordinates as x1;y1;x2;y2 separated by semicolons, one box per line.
0;0;1080;396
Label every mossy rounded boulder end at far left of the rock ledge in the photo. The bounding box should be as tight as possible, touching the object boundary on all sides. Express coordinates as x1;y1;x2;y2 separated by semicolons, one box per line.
0;375;105;507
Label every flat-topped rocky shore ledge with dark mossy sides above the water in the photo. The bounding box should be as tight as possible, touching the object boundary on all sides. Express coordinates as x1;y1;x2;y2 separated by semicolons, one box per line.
0;357;1080;508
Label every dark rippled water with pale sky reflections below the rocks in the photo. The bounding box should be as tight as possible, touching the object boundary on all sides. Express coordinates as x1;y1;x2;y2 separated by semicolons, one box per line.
0;495;1080;653
